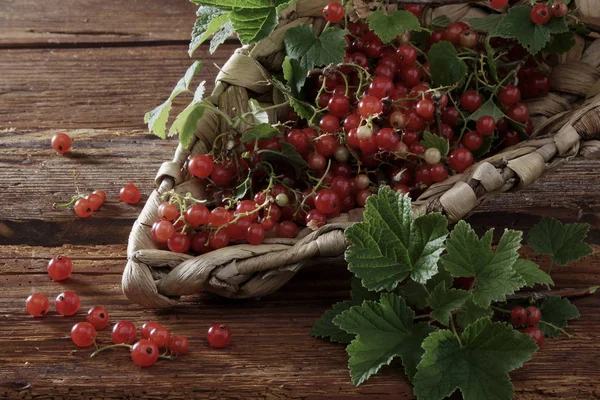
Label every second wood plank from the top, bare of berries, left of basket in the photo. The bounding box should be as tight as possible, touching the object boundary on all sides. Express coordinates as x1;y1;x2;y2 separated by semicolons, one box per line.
0;44;238;129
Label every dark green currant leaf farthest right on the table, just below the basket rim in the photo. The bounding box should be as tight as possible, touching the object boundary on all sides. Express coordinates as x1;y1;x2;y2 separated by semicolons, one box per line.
527;217;593;265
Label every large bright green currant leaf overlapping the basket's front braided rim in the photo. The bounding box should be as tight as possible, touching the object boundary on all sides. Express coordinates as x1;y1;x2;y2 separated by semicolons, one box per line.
345;187;448;290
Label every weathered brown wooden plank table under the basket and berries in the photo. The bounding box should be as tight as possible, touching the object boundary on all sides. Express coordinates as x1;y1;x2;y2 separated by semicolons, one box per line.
0;0;600;400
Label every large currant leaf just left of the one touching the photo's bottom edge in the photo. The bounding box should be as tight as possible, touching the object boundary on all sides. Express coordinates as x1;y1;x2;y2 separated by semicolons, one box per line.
333;293;435;386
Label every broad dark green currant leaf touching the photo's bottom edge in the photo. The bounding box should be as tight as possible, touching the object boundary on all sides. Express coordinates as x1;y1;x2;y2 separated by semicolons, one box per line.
413;318;538;400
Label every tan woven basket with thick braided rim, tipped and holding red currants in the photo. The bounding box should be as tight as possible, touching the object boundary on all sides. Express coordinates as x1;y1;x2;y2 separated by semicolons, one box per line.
122;0;600;308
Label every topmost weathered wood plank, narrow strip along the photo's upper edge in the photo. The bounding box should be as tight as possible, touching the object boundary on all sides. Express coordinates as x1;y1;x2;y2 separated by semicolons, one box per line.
0;0;196;48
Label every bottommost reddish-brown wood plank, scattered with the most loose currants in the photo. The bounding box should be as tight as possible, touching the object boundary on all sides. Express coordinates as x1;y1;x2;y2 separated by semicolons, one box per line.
0;245;600;400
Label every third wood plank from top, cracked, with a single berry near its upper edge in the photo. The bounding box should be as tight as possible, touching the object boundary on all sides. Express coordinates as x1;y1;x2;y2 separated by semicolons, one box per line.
0;129;600;246
